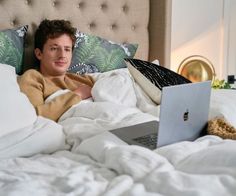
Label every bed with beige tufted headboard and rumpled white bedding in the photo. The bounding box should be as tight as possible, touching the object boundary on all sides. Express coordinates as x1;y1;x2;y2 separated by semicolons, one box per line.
0;0;236;196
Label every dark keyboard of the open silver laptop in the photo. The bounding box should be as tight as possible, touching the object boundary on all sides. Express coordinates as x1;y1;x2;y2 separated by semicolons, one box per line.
133;133;157;149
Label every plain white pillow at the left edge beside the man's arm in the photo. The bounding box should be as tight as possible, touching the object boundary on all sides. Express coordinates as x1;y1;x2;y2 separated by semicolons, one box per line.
0;64;37;137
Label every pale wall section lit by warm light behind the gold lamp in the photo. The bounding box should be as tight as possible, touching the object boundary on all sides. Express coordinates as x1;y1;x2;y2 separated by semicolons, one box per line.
170;0;224;78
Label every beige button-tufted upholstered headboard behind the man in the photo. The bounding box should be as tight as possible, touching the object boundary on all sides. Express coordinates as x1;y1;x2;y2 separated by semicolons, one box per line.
0;0;171;68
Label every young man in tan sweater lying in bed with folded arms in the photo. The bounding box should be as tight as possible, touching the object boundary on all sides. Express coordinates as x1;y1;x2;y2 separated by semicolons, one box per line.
18;20;94;121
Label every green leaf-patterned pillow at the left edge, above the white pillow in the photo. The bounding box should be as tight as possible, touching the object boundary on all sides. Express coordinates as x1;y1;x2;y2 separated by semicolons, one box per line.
0;25;28;74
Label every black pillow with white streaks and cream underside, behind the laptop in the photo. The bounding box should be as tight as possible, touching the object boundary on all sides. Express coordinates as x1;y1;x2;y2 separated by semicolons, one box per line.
125;59;191;104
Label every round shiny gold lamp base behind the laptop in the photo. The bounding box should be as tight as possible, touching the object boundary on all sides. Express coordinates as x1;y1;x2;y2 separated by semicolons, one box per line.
177;55;215;82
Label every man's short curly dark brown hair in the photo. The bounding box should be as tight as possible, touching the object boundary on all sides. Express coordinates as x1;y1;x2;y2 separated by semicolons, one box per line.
34;19;76;51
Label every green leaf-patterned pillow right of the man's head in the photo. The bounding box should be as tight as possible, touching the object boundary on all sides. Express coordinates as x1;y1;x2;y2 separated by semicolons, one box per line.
68;30;138;74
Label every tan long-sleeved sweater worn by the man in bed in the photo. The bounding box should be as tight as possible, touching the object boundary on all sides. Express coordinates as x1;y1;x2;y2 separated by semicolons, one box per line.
18;69;94;121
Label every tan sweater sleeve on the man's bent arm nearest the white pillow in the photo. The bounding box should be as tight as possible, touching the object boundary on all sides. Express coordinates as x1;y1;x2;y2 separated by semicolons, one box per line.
18;71;81;121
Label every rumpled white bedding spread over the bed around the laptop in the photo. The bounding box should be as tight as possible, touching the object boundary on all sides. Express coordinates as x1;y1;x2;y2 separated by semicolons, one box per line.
0;65;236;196
